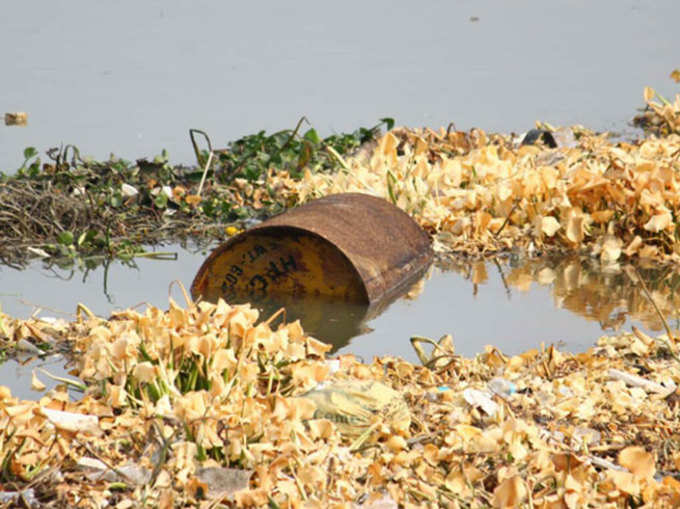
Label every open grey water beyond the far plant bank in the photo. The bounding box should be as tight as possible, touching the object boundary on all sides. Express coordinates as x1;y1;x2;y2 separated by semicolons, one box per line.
0;0;680;172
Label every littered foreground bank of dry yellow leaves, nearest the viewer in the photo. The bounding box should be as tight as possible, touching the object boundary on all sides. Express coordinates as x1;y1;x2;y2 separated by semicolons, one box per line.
0;301;680;508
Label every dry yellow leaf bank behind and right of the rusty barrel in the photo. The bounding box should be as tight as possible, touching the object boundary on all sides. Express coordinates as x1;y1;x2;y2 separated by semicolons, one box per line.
273;92;680;264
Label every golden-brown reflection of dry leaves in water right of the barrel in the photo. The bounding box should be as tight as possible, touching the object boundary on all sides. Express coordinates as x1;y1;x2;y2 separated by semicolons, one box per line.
440;256;680;331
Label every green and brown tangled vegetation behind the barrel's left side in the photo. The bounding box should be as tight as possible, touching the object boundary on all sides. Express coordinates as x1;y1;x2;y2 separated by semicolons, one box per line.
0;119;394;266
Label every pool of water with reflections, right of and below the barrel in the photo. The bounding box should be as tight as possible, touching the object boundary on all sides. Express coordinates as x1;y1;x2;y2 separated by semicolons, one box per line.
251;257;680;362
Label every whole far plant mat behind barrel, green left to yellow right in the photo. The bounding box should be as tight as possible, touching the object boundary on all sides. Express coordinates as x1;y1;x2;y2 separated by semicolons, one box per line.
0;89;680;272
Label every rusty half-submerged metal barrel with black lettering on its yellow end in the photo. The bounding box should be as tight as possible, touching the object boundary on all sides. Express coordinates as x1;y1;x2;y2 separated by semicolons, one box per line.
191;193;432;304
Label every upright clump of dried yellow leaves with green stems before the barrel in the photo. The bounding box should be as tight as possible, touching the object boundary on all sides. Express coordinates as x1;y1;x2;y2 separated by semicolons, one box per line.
79;290;330;466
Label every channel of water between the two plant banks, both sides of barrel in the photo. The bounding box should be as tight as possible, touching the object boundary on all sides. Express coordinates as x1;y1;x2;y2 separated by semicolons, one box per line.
0;249;680;379
